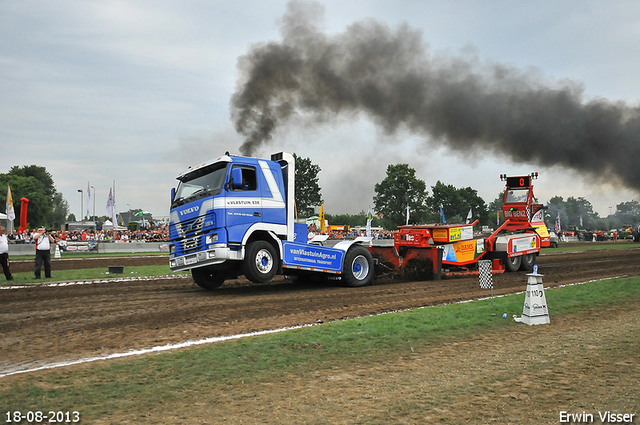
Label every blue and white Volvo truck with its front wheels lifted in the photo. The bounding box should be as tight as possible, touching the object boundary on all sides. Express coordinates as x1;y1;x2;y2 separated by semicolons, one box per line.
169;152;373;289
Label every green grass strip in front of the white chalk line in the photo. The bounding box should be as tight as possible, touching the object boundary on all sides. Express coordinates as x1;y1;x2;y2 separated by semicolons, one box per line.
0;277;640;423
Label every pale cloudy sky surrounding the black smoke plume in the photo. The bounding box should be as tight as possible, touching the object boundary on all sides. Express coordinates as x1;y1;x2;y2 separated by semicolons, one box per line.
0;0;640;217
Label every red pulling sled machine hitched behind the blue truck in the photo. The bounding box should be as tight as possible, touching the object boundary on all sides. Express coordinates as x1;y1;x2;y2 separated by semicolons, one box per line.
369;173;549;279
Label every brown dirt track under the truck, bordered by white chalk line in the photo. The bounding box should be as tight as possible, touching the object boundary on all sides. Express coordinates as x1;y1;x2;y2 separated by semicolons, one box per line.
0;242;640;374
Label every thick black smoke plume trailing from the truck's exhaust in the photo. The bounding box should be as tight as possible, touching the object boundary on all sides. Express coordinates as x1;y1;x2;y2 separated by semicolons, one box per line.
231;2;640;190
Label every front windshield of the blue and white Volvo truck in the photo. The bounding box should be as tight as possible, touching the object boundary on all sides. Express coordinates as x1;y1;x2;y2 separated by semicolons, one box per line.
171;163;227;208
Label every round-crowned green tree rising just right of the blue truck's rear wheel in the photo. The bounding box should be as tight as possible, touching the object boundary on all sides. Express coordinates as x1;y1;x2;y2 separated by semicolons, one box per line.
373;164;427;226
